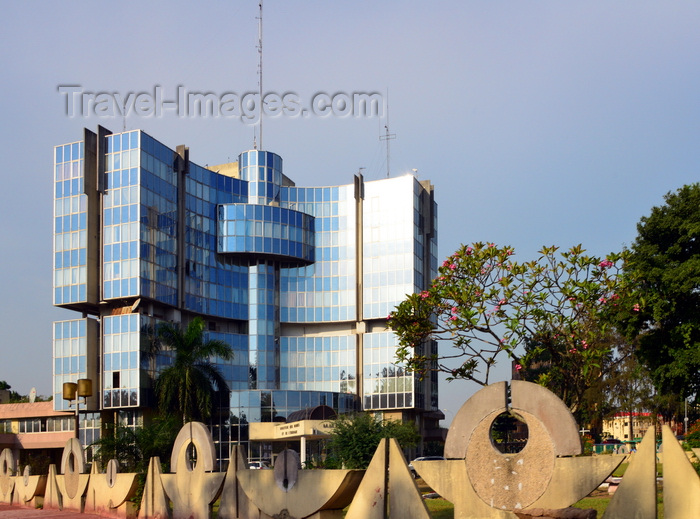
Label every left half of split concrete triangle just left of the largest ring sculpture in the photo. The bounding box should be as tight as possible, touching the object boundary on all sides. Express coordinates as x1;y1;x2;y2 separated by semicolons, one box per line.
345;439;388;519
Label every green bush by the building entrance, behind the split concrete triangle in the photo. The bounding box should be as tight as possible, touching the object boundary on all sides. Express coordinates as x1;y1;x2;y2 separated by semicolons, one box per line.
326;413;420;469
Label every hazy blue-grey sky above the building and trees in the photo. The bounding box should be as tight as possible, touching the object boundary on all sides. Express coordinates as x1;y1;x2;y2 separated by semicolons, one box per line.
0;0;700;421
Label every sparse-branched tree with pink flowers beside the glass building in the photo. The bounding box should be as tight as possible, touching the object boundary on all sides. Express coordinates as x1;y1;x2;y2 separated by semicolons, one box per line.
387;243;634;414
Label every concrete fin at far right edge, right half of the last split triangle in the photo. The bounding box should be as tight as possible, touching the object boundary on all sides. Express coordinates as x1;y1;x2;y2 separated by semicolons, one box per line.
662;425;700;519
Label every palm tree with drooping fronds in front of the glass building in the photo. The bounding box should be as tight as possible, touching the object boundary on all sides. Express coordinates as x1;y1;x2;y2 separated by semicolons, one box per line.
155;317;233;423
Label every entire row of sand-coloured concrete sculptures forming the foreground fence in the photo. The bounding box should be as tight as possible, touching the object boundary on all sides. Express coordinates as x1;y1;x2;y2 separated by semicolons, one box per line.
5;381;700;519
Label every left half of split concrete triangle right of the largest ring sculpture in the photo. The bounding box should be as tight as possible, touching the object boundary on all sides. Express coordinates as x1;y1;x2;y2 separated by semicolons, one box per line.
603;427;656;519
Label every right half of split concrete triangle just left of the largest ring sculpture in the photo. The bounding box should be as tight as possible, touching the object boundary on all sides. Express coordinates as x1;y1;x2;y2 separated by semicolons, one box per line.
389;438;430;519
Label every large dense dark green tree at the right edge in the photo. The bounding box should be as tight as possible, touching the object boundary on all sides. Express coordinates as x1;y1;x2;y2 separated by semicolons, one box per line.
621;184;700;397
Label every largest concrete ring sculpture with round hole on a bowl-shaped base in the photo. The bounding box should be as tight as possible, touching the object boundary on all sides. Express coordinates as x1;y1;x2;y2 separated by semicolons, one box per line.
414;381;624;519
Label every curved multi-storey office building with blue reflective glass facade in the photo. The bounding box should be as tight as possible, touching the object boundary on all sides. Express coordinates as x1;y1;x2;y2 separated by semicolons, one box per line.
54;128;438;457
